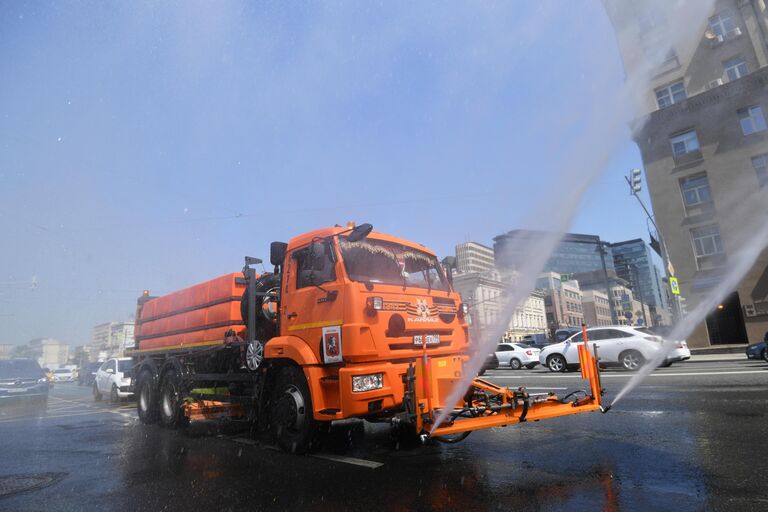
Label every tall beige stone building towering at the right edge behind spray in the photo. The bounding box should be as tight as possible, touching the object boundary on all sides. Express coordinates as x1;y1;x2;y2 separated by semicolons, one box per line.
604;0;768;347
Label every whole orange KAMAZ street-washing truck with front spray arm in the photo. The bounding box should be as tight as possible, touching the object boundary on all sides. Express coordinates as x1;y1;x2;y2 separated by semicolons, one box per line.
132;224;602;453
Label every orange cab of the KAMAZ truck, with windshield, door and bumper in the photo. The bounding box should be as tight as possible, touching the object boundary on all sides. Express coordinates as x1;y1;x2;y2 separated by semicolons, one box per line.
264;226;468;421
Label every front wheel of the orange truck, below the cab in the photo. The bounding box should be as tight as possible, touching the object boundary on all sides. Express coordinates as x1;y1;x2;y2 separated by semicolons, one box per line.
270;366;318;453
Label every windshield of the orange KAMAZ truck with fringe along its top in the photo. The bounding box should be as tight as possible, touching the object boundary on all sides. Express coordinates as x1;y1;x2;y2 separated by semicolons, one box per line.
339;237;449;291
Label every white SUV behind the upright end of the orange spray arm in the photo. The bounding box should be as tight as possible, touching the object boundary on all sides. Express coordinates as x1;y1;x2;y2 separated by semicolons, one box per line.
539;325;690;372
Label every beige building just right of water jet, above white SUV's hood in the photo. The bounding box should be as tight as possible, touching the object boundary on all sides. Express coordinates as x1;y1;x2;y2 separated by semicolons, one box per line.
536;272;584;334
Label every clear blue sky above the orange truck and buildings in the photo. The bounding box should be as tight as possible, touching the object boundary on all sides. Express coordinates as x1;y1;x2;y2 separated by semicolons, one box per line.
0;1;660;344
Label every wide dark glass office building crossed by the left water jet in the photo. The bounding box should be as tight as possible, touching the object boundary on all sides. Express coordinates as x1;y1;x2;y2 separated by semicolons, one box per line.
493;229;613;274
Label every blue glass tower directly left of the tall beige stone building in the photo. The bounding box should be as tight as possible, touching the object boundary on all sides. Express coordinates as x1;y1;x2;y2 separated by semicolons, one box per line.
611;238;669;324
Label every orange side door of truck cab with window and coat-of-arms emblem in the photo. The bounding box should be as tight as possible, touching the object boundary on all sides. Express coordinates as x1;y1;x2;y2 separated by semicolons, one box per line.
280;239;343;362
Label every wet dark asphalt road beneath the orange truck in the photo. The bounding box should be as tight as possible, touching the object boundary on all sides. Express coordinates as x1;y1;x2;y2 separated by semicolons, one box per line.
0;360;768;512
